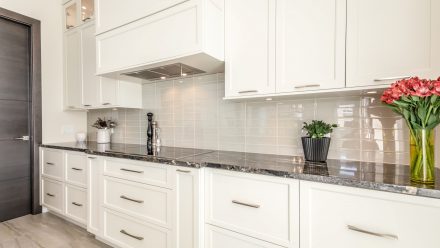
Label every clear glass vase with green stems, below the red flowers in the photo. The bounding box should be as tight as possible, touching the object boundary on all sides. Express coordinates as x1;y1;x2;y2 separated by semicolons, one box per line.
410;128;435;184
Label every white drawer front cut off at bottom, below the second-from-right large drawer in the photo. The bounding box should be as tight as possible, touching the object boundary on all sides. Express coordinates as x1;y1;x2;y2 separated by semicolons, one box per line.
205;225;282;248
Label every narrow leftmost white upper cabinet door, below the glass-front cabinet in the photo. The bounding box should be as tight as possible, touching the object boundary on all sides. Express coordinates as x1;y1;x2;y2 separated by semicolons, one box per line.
64;30;82;109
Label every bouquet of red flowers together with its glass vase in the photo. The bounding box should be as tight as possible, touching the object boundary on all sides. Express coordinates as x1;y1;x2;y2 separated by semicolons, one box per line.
381;77;440;184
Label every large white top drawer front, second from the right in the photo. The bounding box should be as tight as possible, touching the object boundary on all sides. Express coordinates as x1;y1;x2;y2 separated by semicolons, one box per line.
206;169;299;246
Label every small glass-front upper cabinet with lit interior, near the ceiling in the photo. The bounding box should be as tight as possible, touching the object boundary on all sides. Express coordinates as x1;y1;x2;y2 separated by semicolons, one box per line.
63;0;95;30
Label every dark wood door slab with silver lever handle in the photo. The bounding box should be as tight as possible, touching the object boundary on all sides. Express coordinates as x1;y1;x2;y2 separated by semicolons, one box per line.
0;17;32;221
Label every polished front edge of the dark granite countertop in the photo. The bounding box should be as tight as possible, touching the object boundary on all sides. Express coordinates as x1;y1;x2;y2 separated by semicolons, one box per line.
40;144;440;199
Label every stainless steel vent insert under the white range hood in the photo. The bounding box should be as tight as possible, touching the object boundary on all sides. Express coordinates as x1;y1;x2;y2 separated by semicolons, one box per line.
123;63;206;81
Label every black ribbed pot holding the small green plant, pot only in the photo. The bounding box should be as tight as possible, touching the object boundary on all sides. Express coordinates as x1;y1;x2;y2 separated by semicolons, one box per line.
301;137;330;162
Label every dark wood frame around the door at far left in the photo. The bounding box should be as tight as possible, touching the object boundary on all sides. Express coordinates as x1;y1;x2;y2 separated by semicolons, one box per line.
0;8;42;214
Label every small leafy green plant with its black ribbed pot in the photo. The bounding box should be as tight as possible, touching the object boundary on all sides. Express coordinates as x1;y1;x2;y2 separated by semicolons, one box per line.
301;120;337;162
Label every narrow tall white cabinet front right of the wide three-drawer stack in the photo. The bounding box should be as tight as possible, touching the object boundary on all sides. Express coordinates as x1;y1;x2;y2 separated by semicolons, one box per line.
174;167;203;248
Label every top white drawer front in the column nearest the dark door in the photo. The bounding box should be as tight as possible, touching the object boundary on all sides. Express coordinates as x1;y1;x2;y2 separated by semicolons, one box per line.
41;149;64;180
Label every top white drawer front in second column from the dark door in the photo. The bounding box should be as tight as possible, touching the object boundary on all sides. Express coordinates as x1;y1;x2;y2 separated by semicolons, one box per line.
66;152;87;187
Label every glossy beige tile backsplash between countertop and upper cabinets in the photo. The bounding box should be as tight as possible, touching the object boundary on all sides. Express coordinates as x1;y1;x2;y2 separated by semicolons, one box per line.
87;74;440;167
